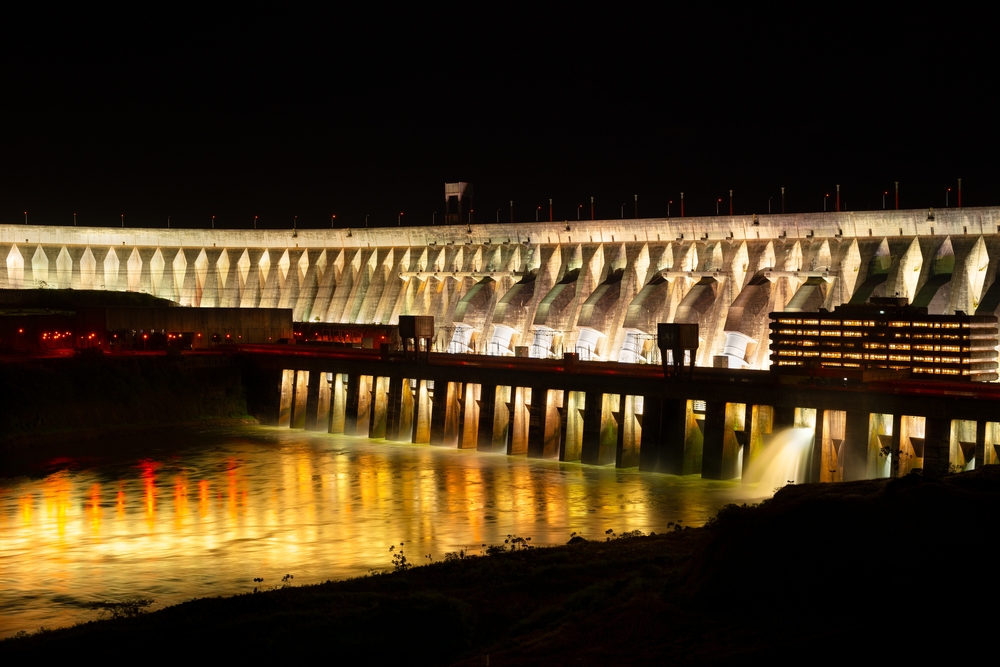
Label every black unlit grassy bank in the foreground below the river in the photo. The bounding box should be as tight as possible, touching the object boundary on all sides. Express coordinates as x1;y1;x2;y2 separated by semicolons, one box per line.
0;466;1000;665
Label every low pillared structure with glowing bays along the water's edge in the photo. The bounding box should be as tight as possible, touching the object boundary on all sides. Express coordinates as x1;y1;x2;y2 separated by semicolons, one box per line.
232;345;1000;481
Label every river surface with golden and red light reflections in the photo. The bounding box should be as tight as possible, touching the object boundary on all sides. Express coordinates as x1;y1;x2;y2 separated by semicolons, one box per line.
0;427;752;637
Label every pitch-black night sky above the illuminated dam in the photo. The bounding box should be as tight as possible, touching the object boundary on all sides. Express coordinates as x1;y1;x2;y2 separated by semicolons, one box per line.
0;5;1000;227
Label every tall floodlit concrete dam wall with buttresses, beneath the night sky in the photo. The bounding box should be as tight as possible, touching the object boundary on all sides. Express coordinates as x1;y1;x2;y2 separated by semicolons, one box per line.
0;208;1000;369
